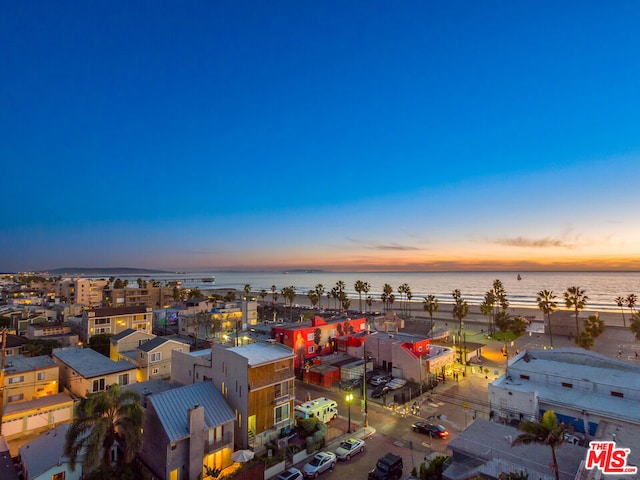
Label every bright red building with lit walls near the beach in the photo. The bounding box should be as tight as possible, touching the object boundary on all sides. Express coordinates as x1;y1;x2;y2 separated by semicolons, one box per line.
271;317;367;368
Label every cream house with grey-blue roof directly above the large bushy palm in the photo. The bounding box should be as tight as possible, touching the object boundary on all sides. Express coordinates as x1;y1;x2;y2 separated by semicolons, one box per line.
52;348;137;397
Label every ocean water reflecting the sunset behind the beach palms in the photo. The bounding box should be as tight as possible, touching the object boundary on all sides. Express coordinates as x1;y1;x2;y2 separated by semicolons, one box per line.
120;271;640;312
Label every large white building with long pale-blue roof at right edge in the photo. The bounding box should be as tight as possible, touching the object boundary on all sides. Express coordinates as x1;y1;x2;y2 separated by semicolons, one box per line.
489;348;640;465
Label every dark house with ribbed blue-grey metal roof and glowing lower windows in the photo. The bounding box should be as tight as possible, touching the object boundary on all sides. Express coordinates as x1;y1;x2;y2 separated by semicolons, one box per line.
138;382;236;480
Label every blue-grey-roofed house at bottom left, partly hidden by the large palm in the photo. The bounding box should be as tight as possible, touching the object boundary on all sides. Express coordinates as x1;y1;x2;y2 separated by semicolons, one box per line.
18;424;84;480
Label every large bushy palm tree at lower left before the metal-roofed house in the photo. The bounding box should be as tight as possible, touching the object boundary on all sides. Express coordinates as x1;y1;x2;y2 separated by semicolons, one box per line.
64;385;145;472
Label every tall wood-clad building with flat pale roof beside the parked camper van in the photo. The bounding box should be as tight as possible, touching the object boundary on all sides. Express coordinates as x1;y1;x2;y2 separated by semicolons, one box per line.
172;343;295;449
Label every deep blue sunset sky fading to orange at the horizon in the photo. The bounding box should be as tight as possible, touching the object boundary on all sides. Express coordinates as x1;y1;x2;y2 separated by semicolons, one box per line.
0;0;640;272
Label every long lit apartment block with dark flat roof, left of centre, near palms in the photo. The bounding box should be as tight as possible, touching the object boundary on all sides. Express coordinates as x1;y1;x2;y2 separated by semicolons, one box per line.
81;307;153;342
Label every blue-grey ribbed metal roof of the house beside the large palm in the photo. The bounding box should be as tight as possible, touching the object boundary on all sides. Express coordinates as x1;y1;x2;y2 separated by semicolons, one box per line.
149;382;236;442
